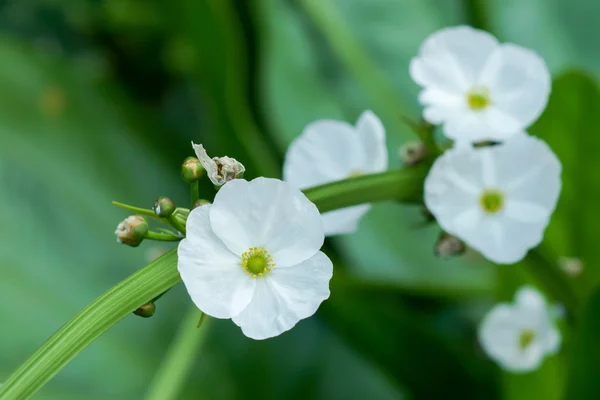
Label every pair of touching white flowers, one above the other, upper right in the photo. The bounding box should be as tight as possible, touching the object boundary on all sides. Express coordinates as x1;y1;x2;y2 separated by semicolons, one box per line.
410;26;561;264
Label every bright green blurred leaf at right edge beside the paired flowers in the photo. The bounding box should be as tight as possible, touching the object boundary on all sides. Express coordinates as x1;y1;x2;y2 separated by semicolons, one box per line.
530;72;600;299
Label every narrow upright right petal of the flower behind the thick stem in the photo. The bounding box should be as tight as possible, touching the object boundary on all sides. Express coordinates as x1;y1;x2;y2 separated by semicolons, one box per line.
356;110;388;173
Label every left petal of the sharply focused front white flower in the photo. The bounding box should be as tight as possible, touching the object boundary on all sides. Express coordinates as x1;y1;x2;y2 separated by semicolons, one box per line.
177;205;255;318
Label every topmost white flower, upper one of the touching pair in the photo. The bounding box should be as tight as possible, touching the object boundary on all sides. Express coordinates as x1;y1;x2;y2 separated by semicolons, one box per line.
410;26;551;142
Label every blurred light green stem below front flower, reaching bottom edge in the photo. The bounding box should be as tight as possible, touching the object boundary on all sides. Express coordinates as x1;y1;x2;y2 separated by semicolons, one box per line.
146;307;208;400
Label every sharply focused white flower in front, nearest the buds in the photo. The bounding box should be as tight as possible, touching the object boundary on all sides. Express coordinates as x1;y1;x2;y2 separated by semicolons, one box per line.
178;178;333;339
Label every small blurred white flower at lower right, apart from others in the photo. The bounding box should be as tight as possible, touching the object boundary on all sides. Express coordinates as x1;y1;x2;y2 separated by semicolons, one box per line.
479;287;561;373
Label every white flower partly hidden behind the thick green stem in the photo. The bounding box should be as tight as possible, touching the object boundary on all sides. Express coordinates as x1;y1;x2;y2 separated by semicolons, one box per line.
283;111;388;236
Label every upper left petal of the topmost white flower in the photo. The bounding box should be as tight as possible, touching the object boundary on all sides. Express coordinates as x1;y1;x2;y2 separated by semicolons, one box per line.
410;26;498;93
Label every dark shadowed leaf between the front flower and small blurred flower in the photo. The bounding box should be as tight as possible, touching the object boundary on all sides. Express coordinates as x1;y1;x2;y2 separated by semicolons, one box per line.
322;273;497;399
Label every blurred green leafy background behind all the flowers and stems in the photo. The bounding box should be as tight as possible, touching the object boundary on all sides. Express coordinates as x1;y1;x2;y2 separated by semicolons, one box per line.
0;0;600;399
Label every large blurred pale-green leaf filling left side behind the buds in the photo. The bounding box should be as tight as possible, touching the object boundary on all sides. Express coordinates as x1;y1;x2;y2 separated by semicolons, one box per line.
0;38;187;398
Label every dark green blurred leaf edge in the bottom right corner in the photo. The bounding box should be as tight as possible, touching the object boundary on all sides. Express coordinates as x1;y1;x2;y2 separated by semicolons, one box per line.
564;291;600;400
